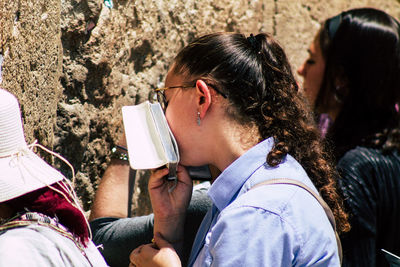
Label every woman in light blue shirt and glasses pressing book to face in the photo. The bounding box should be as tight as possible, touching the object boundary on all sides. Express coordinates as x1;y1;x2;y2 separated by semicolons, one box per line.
130;33;349;266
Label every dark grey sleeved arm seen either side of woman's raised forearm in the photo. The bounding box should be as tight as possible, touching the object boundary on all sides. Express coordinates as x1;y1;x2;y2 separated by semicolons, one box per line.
90;183;211;267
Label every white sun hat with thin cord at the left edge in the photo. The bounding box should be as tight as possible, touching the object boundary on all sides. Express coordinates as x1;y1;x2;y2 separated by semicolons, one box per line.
0;88;65;202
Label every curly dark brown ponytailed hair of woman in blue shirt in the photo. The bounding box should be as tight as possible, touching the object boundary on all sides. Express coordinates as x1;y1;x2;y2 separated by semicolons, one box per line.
173;33;350;232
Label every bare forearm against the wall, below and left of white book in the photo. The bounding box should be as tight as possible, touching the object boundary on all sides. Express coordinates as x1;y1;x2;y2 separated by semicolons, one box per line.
89;159;130;221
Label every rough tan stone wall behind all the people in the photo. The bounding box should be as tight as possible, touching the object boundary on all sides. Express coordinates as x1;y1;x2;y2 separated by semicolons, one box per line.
0;0;400;216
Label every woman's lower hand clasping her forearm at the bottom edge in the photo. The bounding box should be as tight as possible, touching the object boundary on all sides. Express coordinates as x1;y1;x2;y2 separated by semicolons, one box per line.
129;233;181;267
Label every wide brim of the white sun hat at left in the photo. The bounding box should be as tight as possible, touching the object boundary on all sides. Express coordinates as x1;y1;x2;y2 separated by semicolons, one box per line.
0;149;65;202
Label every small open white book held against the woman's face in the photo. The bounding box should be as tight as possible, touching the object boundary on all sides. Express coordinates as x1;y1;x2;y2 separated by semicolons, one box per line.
122;101;179;180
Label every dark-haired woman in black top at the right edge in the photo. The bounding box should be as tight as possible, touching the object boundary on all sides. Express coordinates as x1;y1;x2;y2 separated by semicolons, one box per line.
298;8;400;266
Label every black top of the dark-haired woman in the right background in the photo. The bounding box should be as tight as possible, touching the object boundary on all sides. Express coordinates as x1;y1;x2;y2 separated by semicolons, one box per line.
338;147;400;267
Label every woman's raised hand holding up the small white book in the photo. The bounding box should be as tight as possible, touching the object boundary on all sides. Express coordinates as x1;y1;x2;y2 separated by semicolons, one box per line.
148;165;193;247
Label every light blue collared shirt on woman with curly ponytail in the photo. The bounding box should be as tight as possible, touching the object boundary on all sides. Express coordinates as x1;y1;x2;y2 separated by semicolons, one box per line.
189;138;340;266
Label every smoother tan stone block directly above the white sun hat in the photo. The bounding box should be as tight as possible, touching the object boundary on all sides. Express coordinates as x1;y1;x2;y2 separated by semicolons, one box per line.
0;0;63;148
